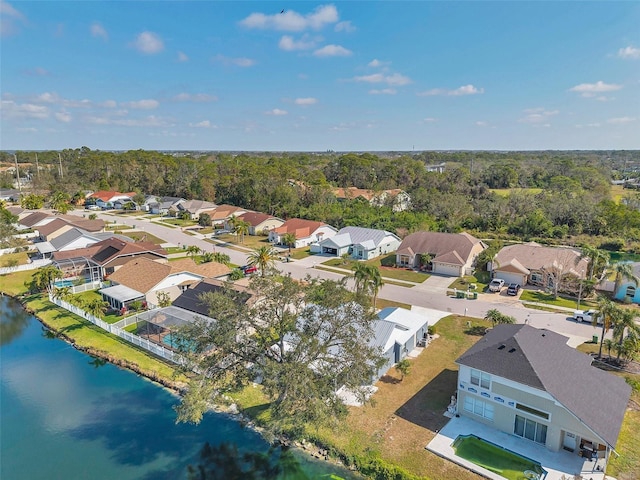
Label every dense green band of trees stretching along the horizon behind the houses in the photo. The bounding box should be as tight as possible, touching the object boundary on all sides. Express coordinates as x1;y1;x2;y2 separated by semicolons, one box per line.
0;147;640;246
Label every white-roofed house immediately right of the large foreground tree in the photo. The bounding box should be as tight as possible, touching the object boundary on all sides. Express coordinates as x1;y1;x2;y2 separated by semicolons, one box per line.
371;307;429;382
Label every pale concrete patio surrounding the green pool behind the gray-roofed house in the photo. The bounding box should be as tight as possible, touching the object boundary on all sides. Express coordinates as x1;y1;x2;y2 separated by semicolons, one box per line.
425;417;611;480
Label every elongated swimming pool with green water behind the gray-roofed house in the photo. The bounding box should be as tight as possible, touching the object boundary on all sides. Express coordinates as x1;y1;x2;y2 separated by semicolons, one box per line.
453;435;542;480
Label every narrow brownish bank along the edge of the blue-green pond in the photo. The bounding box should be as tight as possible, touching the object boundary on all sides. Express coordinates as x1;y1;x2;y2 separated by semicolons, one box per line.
5;291;356;478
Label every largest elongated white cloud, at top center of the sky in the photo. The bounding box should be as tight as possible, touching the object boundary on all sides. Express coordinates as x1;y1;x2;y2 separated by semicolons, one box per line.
240;5;339;32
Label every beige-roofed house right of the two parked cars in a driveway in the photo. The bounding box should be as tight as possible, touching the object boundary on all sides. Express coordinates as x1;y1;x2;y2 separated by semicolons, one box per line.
490;242;589;293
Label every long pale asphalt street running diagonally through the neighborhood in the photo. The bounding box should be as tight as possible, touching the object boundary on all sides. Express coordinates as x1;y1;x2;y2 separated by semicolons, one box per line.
97;212;601;345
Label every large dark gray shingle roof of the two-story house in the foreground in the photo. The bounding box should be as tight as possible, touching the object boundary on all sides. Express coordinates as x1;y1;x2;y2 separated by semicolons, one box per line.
456;325;631;447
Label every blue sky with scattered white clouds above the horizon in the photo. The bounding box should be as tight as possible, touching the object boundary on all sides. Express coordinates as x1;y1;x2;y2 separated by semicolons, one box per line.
0;0;640;151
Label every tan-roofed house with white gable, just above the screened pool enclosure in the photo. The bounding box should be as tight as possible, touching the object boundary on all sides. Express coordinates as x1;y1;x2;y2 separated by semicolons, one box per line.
103;257;231;310
